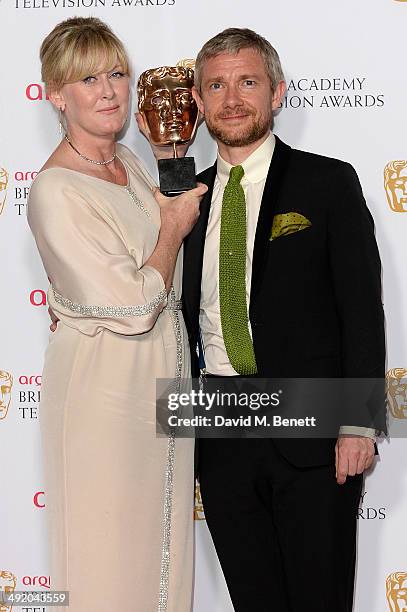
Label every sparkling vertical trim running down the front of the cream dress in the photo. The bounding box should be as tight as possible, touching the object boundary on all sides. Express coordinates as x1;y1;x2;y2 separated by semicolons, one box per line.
157;287;182;612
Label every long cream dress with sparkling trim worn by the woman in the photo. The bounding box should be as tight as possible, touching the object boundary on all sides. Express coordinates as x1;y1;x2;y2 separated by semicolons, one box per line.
28;145;194;612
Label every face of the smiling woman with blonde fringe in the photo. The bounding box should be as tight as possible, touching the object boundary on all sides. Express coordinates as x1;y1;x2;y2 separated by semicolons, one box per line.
60;66;130;136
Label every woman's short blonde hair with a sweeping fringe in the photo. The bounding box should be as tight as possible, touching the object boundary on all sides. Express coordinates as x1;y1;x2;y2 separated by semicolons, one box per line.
40;17;130;91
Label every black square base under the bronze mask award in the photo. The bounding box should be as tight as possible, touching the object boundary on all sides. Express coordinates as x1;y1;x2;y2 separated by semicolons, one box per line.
158;157;196;196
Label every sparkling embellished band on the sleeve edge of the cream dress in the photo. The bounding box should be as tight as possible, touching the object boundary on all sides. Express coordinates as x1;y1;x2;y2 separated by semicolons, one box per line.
52;287;167;318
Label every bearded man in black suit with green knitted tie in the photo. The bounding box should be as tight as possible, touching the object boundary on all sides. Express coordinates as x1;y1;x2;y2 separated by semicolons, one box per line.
183;28;385;612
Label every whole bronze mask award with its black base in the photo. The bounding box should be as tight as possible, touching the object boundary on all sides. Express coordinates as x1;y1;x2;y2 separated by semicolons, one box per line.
137;66;198;196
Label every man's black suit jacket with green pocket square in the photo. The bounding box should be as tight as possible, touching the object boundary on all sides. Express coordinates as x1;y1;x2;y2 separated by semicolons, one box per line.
183;138;386;466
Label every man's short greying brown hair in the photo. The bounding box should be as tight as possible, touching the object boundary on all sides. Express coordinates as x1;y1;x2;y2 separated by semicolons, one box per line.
195;28;285;91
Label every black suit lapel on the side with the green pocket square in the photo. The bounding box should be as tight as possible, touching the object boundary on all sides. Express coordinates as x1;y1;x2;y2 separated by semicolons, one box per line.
250;136;291;312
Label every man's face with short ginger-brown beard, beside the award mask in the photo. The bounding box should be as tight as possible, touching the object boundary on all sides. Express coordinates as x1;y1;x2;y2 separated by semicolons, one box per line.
194;49;281;147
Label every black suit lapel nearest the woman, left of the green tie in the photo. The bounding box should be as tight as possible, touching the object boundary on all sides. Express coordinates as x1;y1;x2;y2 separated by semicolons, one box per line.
182;163;216;331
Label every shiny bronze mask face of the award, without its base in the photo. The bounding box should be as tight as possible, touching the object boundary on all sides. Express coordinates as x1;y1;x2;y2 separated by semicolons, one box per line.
141;75;198;145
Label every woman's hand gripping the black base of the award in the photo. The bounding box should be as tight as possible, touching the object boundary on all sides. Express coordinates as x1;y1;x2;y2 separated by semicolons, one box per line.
154;183;208;244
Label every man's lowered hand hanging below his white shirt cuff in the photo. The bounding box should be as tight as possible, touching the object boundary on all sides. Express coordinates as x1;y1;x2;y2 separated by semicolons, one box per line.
335;435;374;484
